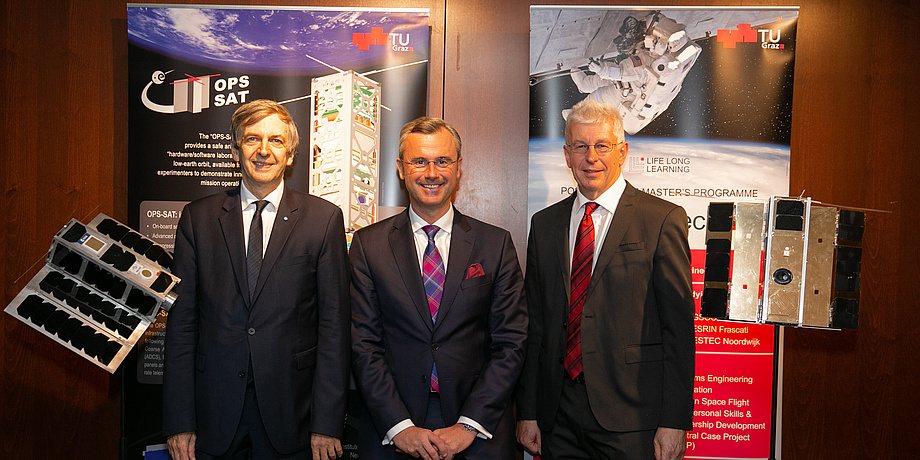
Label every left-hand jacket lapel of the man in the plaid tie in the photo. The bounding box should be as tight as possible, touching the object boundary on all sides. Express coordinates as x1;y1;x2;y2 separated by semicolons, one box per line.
388;212;433;330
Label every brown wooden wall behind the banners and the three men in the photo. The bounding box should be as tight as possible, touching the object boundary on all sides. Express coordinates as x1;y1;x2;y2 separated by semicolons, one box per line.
0;0;920;459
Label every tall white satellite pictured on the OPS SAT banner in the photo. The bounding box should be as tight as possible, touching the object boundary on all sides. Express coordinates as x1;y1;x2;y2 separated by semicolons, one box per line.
310;70;380;236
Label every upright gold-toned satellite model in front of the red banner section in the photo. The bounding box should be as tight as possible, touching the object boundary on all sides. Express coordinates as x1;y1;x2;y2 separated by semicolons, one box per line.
700;197;864;329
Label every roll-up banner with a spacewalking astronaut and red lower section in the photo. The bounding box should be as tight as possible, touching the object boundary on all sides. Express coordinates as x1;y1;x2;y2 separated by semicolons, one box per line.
528;6;798;459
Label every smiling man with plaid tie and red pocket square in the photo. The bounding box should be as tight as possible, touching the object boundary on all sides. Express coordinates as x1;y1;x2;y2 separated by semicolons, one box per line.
349;117;527;460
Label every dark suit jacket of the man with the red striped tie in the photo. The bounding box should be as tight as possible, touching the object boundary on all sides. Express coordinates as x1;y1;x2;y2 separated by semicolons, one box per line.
518;183;695;431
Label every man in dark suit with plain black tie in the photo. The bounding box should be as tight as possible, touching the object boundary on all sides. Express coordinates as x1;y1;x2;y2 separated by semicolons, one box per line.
163;100;350;460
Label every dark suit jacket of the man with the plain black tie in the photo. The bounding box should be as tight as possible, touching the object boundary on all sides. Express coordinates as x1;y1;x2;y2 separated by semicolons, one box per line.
163;185;350;454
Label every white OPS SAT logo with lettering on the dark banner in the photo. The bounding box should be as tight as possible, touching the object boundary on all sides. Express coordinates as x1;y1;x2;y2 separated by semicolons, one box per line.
141;70;249;113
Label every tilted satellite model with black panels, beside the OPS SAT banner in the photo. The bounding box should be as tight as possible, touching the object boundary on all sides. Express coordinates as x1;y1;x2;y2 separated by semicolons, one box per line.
6;214;179;372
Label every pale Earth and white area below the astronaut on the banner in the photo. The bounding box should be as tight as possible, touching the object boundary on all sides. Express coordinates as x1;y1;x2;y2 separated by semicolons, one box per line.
527;137;790;248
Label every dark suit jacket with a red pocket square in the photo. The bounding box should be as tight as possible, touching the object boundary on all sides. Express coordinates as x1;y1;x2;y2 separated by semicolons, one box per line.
349;210;527;459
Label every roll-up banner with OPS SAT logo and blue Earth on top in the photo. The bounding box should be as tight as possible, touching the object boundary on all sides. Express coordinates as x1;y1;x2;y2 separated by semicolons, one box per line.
121;4;430;458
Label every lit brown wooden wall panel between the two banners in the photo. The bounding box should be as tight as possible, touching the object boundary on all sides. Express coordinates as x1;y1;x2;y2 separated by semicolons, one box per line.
444;0;530;250
